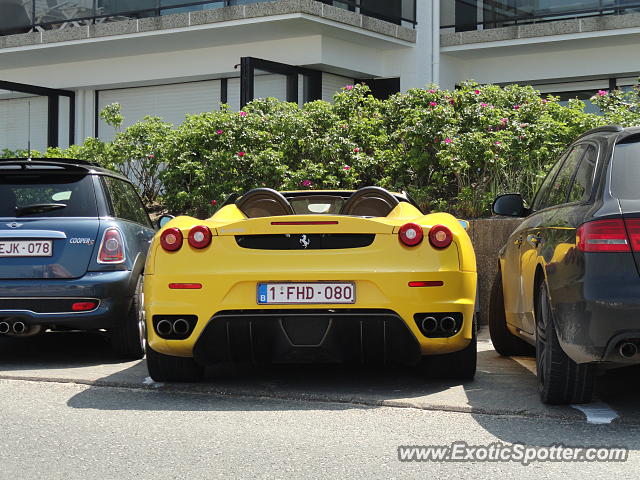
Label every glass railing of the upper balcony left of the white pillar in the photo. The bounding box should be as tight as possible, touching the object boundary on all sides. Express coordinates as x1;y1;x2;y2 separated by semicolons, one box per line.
0;0;417;35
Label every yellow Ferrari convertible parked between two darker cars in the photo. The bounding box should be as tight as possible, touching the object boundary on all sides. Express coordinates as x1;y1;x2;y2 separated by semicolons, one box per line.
144;187;476;381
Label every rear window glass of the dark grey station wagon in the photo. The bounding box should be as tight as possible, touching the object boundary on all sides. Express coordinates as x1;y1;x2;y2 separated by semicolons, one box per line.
611;142;640;200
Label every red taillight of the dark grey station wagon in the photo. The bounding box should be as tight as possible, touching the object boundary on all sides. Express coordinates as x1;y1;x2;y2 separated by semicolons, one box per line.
576;218;640;252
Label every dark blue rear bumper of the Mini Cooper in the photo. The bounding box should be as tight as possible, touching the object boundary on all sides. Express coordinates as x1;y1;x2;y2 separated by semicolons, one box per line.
0;271;135;329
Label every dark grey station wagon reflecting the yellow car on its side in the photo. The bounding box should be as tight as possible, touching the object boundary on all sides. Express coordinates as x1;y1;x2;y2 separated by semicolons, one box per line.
489;126;640;404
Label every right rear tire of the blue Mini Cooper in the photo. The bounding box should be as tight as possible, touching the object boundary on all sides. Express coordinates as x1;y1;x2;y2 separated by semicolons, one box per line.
109;275;147;360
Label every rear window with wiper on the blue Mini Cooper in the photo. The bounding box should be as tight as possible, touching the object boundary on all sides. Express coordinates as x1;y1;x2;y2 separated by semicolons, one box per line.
0;172;98;217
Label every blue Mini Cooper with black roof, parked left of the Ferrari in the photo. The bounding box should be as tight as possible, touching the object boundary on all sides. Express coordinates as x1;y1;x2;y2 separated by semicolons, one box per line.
0;158;155;358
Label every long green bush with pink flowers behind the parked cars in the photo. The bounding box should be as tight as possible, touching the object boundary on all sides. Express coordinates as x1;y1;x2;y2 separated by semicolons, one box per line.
1;82;640;218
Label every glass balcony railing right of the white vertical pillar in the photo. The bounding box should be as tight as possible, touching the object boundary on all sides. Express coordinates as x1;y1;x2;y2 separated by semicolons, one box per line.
440;0;640;32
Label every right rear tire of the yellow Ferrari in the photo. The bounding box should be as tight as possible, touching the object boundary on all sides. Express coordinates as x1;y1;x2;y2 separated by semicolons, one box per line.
422;318;478;380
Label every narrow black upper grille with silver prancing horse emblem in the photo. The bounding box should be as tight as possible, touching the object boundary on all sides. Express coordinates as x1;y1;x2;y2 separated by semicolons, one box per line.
236;233;376;250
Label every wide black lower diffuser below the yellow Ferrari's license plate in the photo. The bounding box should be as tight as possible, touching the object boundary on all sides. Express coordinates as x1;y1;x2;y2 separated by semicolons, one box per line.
193;309;420;365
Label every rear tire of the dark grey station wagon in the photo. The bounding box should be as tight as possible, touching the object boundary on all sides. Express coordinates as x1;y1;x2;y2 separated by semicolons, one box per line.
535;282;595;405
